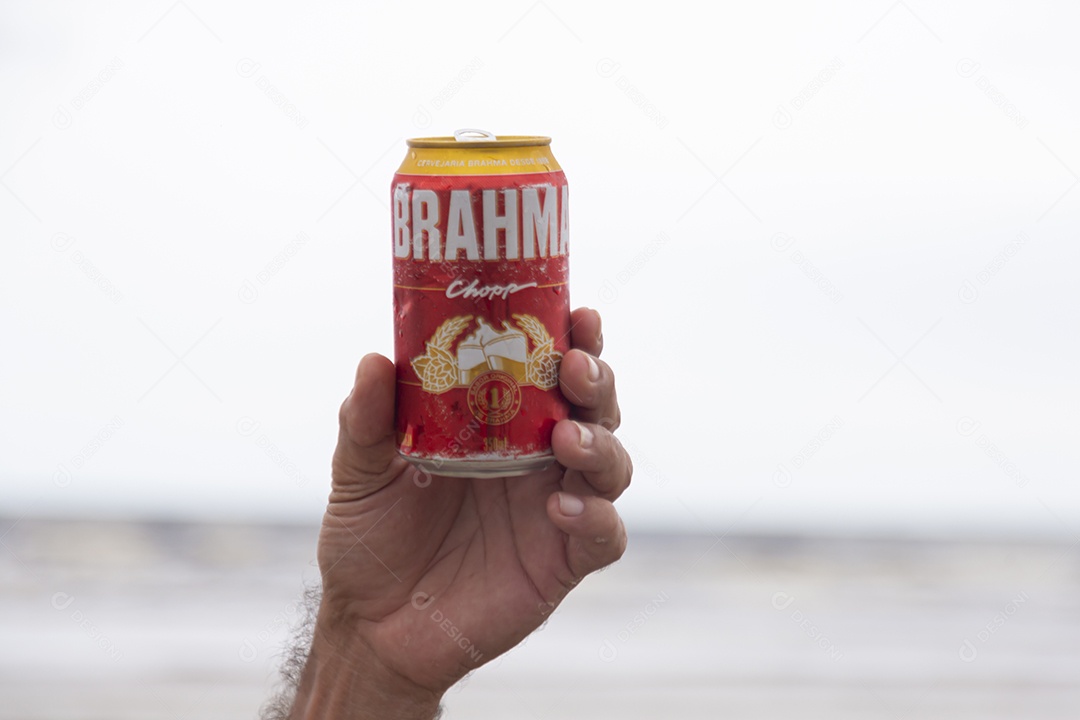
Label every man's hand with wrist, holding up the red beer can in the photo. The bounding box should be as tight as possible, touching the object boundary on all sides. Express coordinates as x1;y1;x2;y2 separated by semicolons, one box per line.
293;309;632;720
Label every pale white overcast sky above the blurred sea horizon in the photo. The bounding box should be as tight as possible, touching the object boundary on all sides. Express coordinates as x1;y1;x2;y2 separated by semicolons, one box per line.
0;0;1080;533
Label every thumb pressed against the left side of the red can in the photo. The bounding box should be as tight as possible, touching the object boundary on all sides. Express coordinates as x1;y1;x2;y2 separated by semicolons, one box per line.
332;353;401;500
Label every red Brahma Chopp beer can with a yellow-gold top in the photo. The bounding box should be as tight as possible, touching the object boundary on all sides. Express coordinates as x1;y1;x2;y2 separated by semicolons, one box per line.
391;131;570;477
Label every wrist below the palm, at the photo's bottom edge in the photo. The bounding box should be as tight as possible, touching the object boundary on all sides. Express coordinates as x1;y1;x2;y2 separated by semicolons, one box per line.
289;604;442;720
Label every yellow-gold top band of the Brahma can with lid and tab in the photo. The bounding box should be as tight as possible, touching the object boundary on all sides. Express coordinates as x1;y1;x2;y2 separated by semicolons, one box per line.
397;130;562;175
